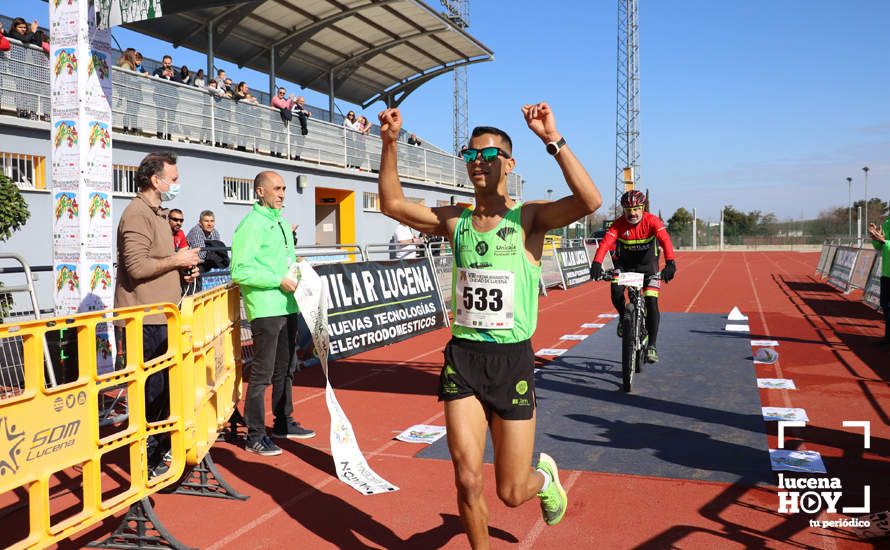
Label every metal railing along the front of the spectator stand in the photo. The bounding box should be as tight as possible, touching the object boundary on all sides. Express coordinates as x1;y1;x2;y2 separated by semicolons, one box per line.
0;40;522;198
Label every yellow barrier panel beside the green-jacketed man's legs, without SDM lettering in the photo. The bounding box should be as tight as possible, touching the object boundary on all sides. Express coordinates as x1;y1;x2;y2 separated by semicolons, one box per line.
180;284;242;466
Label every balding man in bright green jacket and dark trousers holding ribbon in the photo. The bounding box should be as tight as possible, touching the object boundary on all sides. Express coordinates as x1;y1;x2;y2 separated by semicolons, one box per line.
232;171;315;456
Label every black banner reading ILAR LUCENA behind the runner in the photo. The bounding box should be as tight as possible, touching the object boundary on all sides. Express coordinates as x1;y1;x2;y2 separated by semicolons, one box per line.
315;258;446;359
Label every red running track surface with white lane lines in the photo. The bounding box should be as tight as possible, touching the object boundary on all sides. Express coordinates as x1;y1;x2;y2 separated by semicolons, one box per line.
52;252;890;550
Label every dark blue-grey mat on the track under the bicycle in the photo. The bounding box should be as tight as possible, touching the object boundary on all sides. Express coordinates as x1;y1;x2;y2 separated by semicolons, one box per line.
417;313;775;483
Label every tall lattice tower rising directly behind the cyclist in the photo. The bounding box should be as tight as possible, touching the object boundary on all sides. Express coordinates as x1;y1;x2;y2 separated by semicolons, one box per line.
614;0;640;217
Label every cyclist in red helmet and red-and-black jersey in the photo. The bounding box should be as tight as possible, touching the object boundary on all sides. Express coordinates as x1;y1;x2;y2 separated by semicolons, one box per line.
590;189;677;363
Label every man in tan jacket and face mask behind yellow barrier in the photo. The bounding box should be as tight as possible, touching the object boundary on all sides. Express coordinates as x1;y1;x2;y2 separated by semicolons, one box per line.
114;151;200;476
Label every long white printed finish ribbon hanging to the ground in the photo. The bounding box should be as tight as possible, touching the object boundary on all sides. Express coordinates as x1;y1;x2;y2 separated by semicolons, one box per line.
288;261;399;495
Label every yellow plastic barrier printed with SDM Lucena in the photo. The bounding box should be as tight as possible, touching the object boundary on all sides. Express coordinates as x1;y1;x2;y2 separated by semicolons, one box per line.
0;304;184;548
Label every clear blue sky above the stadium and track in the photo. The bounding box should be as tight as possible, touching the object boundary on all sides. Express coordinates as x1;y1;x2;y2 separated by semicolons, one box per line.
13;0;890;219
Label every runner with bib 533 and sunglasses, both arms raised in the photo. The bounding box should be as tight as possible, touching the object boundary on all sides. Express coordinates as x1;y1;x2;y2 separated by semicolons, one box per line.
379;103;602;548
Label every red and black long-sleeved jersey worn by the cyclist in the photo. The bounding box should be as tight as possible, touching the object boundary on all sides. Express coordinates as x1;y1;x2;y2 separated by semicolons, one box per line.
593;212;674;275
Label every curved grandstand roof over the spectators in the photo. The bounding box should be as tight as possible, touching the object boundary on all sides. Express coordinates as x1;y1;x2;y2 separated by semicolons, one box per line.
125;0;494;107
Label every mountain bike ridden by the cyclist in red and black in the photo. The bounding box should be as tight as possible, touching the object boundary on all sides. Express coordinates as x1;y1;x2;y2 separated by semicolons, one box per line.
601;270;648;393
